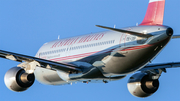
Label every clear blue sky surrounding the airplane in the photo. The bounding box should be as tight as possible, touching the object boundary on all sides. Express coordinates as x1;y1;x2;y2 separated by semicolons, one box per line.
0;0;180;101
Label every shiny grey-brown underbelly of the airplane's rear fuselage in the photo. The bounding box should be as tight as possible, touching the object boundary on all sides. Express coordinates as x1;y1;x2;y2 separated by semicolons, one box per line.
99;38;169;74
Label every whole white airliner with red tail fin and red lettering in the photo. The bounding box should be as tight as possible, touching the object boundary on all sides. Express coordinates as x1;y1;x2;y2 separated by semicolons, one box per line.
0;0;180;98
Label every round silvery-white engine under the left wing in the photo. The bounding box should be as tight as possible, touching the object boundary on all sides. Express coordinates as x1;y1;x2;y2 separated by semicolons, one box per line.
4;67;35;92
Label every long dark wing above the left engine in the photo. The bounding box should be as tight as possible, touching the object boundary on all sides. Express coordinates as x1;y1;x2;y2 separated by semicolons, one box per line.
0;50;81;72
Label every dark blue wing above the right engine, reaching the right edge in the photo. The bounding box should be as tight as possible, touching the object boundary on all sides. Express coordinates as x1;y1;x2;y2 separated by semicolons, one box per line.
139;62;180;71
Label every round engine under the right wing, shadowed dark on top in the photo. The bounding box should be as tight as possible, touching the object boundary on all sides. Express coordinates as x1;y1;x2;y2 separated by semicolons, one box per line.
127;73;159;97
